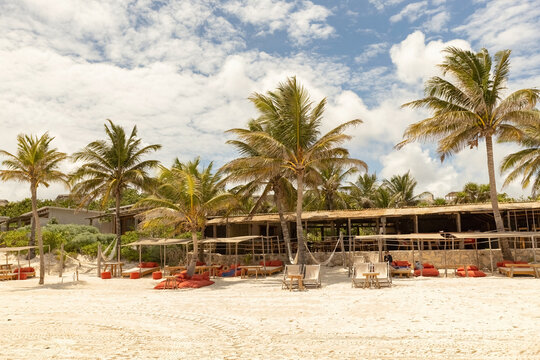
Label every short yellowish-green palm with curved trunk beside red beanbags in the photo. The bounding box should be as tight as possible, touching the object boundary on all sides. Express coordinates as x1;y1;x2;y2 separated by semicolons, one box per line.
138;158;232;275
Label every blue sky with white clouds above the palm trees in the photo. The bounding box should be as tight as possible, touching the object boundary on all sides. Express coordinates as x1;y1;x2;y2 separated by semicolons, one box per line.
0;0;540;201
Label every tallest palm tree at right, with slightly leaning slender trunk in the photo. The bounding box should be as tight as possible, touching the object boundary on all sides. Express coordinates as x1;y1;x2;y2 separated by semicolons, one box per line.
398;47;540;259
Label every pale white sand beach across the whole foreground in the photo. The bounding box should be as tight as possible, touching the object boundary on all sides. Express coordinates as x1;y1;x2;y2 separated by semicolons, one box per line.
0;268;540;359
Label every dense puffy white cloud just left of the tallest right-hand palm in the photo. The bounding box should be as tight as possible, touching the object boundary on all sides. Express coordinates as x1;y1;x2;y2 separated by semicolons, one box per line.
390;31;470;84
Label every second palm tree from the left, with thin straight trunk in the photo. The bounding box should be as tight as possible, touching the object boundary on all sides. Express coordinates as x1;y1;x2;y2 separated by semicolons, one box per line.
70;120;161;261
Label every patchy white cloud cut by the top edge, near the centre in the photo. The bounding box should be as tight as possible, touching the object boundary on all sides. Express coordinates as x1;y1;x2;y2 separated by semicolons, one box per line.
223;0;335;45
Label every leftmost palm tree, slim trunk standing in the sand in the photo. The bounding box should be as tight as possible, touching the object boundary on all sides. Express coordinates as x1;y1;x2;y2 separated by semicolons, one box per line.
0;133;67;285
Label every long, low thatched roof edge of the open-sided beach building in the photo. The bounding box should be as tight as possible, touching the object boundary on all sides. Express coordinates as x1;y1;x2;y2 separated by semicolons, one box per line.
207;201;540;225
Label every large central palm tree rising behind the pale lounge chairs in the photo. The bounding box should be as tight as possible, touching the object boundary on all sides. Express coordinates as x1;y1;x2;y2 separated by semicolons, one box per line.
243;77;367;263
